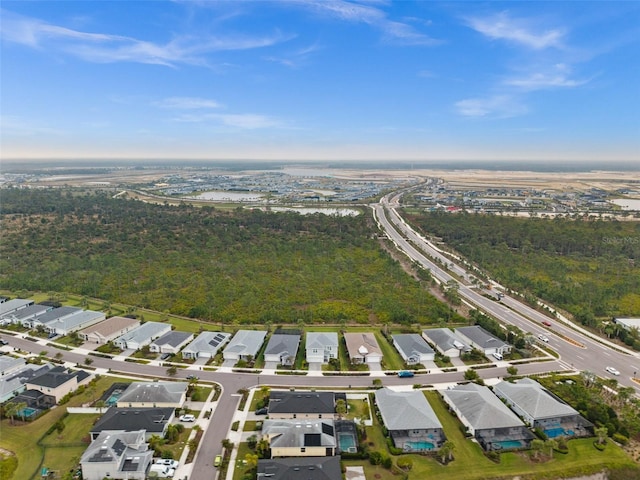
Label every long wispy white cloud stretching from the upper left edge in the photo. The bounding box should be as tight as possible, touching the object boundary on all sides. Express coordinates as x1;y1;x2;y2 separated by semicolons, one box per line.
0;10;291;67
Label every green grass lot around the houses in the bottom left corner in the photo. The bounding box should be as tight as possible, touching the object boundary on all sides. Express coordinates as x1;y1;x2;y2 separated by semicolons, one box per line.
0;377;130;480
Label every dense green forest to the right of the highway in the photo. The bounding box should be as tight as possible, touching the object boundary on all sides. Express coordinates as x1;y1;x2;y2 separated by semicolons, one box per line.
407;212;640;326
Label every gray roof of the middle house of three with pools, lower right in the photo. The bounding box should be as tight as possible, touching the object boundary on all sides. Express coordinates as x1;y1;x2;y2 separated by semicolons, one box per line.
442;383;524;430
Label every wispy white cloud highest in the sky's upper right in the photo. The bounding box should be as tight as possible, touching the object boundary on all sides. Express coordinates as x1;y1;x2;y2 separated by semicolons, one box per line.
467;12;565;50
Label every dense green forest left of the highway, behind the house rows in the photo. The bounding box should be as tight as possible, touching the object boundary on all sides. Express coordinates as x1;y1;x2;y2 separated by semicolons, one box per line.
0;189;460;324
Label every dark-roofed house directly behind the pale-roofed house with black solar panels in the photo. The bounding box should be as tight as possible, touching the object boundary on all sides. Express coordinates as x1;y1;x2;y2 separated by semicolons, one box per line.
269;390;336;419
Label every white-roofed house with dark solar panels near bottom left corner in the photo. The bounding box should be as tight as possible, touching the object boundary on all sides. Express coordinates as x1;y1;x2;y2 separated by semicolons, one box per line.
80;430;153;480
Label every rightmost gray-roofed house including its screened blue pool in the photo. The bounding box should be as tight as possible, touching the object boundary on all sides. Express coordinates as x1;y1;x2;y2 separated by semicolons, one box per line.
493;378;593;438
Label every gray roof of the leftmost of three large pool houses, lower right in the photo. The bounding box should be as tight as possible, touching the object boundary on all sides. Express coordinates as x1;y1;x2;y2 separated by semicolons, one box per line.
376;388;442;430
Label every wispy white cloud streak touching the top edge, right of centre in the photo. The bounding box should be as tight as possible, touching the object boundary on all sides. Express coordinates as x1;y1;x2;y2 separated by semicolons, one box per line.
289;0;442;46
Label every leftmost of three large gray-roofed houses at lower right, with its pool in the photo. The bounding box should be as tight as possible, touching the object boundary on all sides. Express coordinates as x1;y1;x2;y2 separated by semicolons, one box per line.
375;388;447;452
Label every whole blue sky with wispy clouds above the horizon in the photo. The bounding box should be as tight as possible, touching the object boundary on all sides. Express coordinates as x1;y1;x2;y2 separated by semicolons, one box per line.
0;0;640;161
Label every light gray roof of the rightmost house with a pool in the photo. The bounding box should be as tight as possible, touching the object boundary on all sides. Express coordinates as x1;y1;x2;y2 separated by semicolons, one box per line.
493;378;578;420
